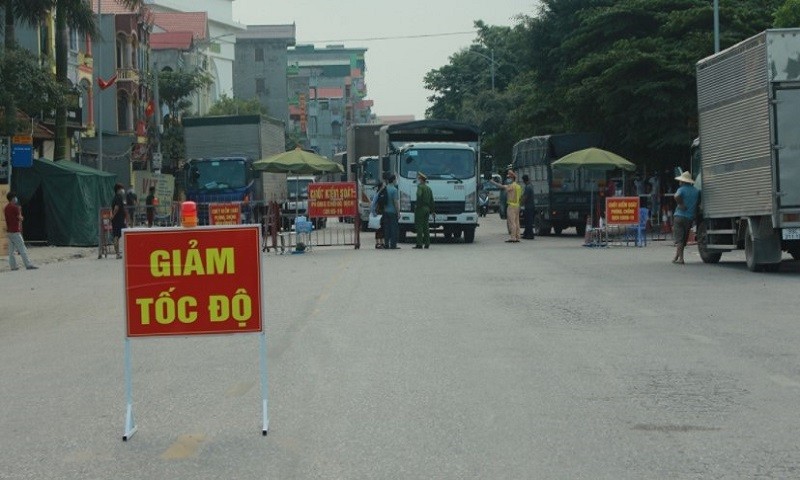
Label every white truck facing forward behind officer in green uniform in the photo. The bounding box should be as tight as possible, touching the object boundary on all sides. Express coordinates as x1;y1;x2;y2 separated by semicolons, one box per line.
379;120;480;243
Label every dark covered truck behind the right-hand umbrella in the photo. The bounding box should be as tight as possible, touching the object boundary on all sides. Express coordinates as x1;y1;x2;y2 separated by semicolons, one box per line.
512;133;602;236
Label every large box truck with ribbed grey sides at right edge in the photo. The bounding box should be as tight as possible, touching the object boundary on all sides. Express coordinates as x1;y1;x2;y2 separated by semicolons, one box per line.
693;28;800;271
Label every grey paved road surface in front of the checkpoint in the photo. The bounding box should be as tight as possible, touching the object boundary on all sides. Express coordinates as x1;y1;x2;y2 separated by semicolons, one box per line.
0;215;800;479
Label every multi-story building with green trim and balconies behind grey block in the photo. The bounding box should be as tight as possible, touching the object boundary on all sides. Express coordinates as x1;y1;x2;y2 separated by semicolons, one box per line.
287;45;373;158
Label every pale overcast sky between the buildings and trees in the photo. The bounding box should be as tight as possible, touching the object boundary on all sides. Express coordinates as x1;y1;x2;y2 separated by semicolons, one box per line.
233;0;537;119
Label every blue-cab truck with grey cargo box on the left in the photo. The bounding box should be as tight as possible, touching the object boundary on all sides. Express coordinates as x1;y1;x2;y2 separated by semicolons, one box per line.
183;115;286;203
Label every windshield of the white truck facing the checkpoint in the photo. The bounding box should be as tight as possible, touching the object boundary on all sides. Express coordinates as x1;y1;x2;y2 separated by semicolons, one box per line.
400;148;475;180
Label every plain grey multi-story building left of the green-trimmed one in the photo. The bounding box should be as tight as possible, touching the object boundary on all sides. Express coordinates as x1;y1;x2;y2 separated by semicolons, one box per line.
233;24;295;124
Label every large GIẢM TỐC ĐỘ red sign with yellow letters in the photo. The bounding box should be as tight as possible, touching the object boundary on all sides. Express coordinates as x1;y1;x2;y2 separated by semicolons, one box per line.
123;225;262;337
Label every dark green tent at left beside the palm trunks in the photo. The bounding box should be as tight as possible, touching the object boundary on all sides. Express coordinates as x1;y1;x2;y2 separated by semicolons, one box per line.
12;159;116;246
